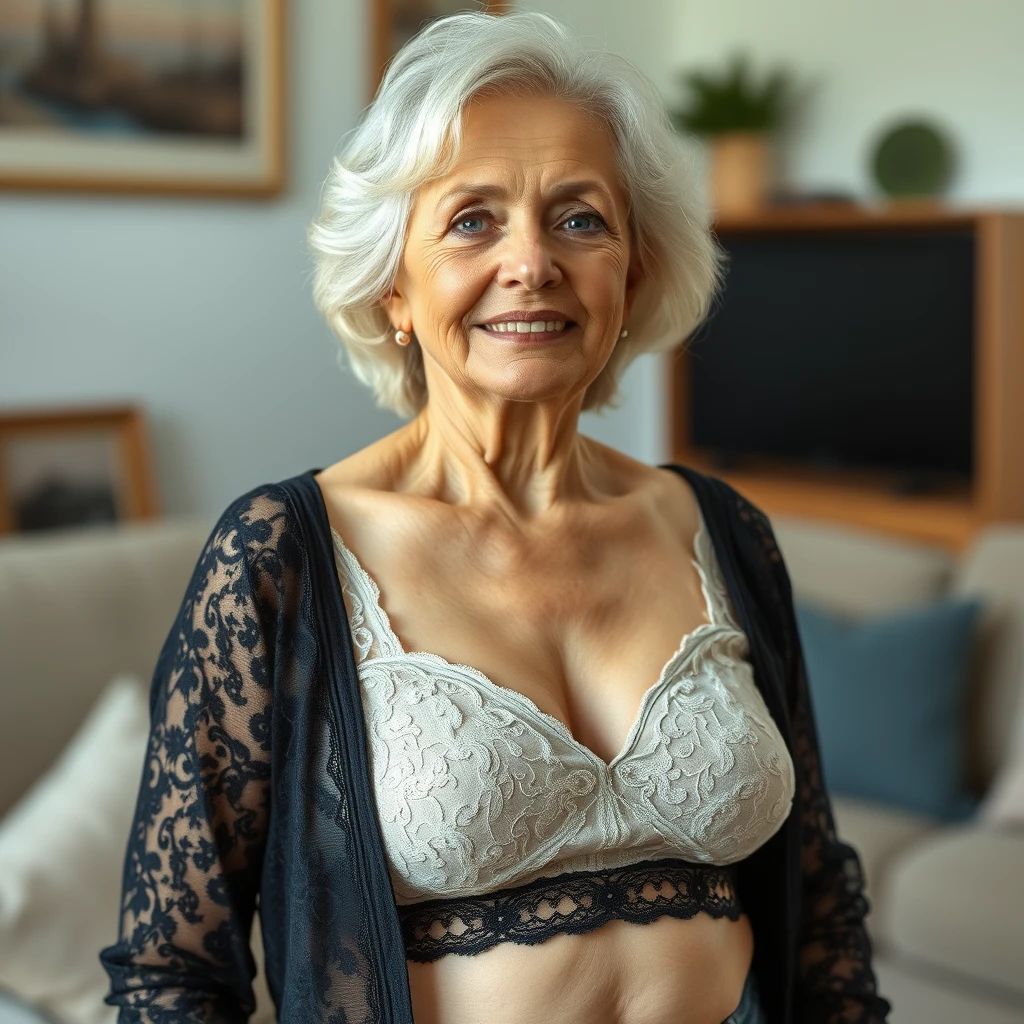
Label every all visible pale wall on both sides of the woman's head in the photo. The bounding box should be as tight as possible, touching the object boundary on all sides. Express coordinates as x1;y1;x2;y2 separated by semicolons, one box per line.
0;0;1024;514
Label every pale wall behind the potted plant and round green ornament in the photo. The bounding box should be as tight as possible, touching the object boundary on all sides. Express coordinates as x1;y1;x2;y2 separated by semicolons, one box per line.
669;0;1024;206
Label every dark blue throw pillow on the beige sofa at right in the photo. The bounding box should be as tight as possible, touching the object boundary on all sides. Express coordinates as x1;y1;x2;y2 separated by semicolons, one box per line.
796;598;981;821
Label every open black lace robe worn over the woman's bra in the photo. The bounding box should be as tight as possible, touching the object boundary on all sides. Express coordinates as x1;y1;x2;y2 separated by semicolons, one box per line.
100;467;890;1024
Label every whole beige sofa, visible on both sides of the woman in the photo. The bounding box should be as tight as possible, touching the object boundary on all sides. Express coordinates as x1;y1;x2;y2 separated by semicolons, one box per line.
0;518;1024;1024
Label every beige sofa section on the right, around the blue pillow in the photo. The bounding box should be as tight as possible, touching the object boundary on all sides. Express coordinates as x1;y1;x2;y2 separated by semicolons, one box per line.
773;516;1024;1024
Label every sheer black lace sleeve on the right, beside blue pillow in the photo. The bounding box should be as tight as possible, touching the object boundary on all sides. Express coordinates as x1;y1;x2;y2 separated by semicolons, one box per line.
739;499;892;1024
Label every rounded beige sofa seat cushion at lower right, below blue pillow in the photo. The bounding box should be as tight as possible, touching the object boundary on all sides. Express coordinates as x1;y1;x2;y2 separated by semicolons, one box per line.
883;824;1024;997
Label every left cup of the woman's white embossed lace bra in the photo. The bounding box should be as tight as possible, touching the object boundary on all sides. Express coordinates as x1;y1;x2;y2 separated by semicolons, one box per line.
359;654;600;900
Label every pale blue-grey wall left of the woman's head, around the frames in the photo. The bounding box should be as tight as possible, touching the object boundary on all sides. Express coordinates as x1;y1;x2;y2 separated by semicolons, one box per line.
0;0;399;514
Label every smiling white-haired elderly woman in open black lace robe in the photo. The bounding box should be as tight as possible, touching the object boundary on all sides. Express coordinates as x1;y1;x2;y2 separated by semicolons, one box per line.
101;13;889;1024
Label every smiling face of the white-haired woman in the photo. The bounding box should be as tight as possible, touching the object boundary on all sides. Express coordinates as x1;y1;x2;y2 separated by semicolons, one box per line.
387;96;639;401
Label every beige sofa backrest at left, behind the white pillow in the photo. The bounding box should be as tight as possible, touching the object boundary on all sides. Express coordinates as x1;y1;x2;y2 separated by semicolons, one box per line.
0;520;209;817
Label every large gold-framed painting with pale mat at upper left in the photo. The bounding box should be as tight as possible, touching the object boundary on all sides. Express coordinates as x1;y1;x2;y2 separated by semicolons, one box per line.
0;0;286;196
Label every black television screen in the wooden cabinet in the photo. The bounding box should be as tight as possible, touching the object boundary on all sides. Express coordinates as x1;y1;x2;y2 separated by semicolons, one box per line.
689;228;975;476
